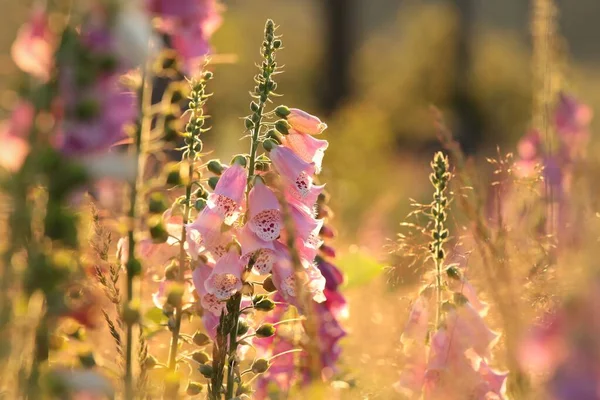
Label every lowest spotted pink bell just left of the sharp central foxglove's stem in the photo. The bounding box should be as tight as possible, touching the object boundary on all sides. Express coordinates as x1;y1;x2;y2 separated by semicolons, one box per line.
204;248;244;300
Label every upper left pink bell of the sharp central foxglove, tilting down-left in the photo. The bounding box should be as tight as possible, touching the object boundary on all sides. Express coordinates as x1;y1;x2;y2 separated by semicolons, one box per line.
207;164;248;225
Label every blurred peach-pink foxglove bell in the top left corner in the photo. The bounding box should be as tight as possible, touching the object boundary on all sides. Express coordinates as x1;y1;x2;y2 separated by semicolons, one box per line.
11;7;56;82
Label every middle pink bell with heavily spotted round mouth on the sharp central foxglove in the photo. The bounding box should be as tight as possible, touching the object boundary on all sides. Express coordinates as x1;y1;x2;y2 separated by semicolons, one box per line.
248;179;283;241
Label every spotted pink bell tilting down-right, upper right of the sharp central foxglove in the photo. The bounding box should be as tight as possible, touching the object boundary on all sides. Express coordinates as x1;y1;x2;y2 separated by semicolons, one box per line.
270;146;315;199
